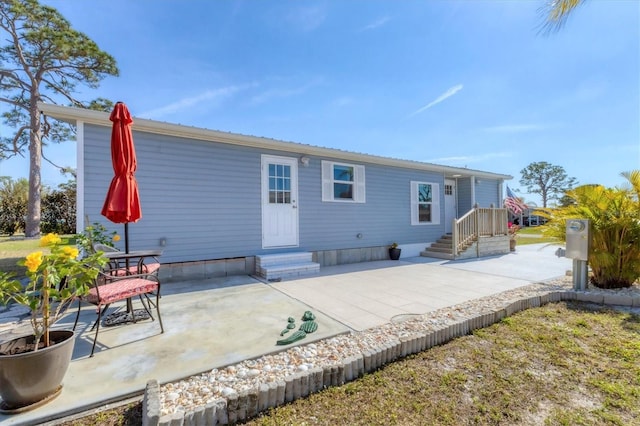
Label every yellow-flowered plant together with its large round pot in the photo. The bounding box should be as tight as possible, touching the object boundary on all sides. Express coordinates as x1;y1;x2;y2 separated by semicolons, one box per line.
0;234;106;413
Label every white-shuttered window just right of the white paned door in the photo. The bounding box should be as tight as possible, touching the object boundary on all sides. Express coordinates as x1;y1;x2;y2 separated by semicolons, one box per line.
322;161;365;203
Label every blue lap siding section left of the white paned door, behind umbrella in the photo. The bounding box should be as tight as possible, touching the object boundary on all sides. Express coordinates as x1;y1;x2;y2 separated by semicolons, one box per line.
84;126;262;262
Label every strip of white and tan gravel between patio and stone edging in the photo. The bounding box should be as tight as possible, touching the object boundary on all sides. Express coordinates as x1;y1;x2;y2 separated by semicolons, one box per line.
160;277;640;416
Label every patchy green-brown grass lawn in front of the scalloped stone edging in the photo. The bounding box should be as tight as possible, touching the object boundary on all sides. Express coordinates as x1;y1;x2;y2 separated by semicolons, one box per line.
57;303;640;426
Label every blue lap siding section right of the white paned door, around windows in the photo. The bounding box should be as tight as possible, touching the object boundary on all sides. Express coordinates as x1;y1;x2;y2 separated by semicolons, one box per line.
299;158;444;251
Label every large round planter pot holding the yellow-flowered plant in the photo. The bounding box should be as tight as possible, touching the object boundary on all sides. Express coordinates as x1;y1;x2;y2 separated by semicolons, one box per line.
0;330;75;413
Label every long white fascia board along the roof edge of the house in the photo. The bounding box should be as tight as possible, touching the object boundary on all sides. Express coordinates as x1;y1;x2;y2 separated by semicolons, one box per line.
38;102;513;180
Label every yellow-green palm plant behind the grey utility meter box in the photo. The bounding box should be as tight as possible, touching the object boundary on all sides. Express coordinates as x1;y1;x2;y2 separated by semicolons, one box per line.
539;170;640;288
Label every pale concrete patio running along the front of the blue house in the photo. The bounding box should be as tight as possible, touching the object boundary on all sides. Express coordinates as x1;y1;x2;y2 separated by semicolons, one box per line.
0;244;571;425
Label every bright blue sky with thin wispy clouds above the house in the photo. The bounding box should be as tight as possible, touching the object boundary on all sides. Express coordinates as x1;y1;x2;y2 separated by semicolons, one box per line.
0;0;640;206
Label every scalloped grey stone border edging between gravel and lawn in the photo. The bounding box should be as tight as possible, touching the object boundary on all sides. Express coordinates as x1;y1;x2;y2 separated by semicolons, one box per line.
142;290;640;426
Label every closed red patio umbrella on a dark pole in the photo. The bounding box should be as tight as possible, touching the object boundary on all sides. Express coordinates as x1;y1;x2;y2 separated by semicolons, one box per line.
101;102;142;253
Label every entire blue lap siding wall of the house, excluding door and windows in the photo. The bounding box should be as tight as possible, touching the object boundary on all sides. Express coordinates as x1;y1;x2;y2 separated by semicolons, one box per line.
79;125;448;262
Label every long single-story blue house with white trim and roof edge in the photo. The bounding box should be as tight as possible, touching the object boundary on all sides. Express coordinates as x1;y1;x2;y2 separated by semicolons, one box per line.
39;103;512;278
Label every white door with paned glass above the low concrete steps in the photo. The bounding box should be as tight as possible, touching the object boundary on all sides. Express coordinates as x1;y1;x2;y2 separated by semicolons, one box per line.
262;155;298;248
